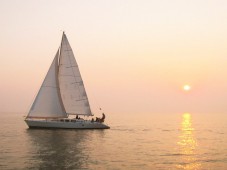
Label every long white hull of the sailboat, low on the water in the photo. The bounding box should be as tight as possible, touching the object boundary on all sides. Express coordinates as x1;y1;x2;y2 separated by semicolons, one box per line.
25;119;110;129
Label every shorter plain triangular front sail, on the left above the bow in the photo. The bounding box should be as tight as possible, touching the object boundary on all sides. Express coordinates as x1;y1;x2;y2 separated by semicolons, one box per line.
27;50;67;118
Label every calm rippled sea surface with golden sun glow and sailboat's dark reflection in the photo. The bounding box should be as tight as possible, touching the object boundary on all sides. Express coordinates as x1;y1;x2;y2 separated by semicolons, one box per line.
0;113;227;170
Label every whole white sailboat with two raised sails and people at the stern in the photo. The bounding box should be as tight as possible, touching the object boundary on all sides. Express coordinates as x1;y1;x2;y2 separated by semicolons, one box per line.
25;32;110;129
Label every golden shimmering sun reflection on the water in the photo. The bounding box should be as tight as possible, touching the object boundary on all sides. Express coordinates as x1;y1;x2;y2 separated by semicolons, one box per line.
177;113;201;170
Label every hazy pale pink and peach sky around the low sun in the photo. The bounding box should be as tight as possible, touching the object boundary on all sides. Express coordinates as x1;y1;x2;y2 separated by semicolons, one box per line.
0;0;227;114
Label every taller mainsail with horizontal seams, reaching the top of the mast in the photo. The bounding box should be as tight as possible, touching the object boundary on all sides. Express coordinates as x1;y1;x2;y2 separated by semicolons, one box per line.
58;33;92;116
